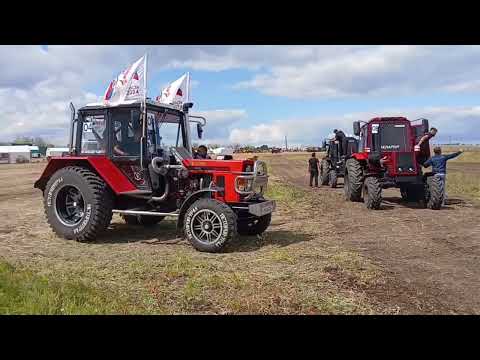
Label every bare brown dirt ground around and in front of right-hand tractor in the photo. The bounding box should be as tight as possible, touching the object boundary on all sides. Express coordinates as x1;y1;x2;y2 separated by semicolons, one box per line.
256;153;480;314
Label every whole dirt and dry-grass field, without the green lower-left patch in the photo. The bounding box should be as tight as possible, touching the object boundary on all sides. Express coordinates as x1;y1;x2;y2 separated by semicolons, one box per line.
0;154;480;314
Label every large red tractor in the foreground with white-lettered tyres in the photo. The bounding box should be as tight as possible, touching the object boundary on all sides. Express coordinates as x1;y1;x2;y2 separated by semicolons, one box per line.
35;100;275;252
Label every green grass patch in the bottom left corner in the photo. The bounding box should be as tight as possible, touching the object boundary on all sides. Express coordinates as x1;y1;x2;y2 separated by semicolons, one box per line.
0;262;139;315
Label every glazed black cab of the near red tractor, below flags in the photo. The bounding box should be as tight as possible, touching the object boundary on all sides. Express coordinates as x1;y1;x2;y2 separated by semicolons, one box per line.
70;101;195;191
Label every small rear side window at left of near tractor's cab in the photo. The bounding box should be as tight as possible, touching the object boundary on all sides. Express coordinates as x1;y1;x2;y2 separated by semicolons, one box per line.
81;114;107;154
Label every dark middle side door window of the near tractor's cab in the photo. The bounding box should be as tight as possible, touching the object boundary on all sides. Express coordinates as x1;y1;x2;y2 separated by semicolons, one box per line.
112;109;142;157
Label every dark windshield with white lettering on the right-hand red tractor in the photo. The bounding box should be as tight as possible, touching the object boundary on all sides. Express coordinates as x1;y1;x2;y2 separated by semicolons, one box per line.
372;123;408;151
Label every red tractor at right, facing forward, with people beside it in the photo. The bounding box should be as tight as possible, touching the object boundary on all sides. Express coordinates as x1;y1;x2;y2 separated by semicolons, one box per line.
344;117;443;209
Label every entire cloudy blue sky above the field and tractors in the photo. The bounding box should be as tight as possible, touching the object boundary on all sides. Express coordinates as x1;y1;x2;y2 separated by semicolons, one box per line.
0;45;480;145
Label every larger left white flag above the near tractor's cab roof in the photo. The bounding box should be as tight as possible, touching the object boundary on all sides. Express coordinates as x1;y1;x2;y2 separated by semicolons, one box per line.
103;56;146;104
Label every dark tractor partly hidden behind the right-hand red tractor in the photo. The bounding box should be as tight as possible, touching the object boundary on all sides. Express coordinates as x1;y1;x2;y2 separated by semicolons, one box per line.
320;137;358;188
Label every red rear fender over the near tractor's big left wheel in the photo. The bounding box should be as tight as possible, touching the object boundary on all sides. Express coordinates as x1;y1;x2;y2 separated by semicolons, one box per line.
34;156;138;195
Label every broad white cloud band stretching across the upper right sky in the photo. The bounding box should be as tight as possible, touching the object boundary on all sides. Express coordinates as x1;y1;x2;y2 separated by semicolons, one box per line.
234;46;480;99
